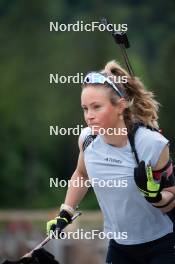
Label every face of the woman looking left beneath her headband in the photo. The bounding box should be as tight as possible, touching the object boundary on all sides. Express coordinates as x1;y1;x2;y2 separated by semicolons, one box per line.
81;85;123;133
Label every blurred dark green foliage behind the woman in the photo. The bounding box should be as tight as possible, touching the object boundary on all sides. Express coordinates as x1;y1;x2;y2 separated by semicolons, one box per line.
0;0;175;209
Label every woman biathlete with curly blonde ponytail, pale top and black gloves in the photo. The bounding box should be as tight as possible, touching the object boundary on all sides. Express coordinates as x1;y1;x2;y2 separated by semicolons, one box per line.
47;61;175;264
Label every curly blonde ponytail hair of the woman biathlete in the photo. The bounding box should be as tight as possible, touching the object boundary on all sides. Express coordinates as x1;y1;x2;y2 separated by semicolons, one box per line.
101;61;159;129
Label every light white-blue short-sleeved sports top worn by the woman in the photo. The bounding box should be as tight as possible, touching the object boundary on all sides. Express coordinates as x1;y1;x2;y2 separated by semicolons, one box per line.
80;127;173;245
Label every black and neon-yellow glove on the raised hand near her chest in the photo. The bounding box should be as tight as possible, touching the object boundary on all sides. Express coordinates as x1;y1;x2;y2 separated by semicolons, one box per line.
134;161;162;203
